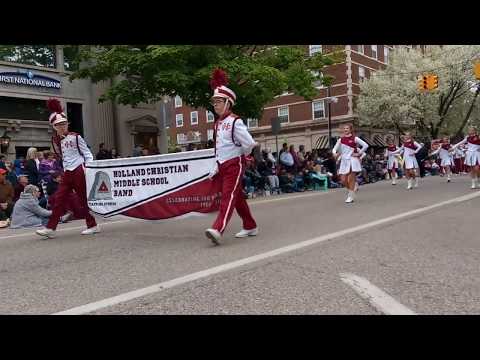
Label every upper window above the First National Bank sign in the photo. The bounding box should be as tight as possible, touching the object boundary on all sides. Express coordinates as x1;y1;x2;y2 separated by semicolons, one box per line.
0;45;56;68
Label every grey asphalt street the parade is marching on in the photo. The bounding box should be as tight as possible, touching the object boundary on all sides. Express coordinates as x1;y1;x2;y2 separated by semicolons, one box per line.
0;176;480;314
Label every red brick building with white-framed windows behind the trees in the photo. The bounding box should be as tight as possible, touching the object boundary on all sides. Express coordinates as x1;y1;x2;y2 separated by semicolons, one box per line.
169;45;425;151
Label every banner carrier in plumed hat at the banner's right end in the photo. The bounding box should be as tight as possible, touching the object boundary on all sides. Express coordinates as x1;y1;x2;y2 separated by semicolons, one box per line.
205;69;258;245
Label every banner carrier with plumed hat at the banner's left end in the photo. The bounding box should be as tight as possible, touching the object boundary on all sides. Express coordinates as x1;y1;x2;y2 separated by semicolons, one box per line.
36;99;100;239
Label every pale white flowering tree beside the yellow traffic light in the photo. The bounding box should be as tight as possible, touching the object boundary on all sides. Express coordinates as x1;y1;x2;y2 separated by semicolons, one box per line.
357;45;480;138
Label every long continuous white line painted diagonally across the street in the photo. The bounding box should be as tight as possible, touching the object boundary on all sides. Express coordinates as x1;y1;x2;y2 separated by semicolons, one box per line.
54;191;480;315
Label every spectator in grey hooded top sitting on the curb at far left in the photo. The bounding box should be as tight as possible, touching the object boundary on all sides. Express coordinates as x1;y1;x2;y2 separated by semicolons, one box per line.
10;185;52;229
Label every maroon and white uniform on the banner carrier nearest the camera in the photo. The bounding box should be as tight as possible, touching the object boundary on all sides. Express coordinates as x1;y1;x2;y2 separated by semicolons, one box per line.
212;113;257;233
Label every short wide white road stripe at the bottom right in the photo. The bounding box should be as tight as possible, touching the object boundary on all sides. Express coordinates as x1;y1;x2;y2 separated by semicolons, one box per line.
340;274;416;315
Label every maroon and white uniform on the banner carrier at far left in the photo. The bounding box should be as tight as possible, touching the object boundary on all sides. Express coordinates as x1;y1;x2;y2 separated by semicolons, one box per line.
46;132;97;230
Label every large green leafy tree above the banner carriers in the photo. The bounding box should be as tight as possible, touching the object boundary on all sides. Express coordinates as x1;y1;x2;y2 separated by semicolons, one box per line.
71;45;344;118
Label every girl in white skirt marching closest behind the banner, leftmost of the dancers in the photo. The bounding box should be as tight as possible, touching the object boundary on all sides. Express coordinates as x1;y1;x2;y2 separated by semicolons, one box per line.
332;124;368;203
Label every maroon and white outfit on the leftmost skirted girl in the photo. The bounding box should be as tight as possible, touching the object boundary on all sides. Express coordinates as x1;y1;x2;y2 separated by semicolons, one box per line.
332;135;368;175
